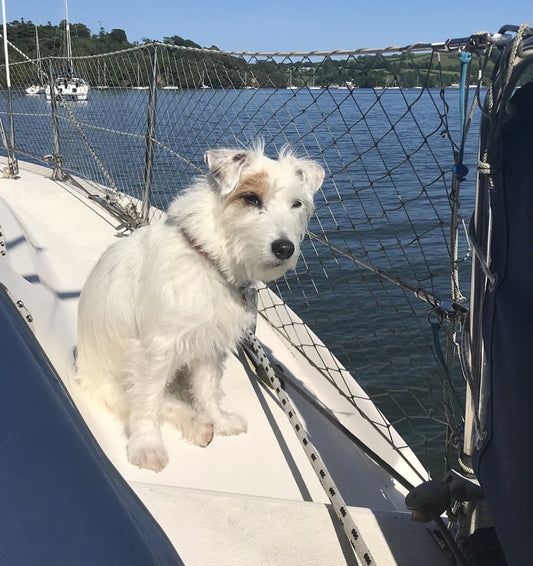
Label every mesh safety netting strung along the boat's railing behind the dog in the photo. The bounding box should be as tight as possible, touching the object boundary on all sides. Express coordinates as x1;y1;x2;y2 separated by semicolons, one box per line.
0;28;512;474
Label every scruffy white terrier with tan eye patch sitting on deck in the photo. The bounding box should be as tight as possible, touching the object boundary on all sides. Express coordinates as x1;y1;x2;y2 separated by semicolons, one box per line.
77;147;324;471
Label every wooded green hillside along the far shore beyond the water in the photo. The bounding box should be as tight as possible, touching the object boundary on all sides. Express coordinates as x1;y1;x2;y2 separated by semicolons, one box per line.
4;20;494;88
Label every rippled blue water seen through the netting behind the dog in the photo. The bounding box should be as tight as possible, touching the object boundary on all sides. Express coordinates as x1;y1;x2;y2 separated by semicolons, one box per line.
2;85;479;474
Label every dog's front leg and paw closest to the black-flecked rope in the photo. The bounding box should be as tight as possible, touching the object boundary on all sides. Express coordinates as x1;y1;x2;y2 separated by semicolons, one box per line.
190;358;247;436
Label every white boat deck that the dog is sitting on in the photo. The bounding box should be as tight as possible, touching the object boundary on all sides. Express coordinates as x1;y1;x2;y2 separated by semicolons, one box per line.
0;158;446;566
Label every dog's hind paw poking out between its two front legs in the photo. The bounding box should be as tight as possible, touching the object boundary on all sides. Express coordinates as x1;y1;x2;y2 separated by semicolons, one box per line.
161;395;214;447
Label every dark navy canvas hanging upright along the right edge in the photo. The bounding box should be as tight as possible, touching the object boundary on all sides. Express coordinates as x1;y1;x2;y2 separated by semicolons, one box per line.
473;83;533;566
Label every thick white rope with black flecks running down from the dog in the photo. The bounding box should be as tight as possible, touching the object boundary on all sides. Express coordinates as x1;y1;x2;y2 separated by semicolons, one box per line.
246;331;376;566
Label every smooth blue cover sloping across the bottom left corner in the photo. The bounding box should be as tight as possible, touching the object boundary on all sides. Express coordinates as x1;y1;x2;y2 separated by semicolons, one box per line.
0;286;182;566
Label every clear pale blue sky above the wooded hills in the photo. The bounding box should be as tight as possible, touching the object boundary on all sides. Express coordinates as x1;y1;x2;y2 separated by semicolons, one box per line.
6;0;533;52
